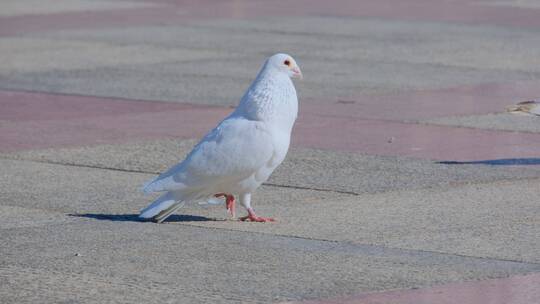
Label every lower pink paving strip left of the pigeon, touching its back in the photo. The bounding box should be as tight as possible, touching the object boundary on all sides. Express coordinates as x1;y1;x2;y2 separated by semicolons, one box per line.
0;108;226;152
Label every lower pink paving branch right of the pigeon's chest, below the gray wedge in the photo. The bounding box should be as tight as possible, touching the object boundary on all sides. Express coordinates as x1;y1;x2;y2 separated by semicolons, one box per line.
292;115;540;161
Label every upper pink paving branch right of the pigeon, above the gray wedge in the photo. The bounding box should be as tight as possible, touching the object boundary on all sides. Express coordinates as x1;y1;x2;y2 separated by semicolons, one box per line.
301;81;540;121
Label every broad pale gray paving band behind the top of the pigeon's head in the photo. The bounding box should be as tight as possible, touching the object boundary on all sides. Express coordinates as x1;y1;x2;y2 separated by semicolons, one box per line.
33;16;540;73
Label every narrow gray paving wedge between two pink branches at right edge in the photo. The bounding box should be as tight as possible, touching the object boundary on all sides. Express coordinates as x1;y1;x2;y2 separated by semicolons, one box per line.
421;113;540;133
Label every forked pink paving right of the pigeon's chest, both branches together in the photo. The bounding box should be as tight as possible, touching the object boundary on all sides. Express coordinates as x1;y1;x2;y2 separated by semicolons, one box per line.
293;82;540;161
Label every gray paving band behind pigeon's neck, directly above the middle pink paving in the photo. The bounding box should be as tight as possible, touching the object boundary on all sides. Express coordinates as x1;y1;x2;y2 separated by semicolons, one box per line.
0;55;540;106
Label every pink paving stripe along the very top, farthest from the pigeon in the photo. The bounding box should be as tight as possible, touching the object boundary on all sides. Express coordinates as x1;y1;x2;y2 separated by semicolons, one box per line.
0;0;540;35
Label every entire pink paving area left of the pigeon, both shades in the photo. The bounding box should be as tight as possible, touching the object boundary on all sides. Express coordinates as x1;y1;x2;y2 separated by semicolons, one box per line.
0;91;231;152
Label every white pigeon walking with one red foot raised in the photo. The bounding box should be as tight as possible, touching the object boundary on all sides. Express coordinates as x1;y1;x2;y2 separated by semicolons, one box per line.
139;54;302;223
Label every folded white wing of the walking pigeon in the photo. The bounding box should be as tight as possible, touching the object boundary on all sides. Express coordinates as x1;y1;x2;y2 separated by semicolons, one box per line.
144;117;274;192
